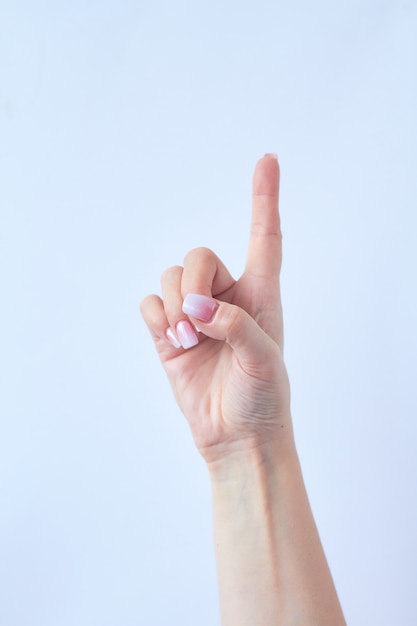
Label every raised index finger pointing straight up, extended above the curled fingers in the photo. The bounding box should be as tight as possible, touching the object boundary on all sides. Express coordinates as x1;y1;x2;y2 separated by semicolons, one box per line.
245;154;282;279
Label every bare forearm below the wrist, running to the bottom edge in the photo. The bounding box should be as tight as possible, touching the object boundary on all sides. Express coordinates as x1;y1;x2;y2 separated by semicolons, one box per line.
209;434;345;626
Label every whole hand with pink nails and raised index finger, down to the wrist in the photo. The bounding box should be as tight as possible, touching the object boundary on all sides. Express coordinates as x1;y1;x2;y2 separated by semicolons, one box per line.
141;155;293;463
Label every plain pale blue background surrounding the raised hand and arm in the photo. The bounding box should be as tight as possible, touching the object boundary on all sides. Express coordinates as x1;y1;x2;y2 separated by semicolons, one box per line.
0;0;417;626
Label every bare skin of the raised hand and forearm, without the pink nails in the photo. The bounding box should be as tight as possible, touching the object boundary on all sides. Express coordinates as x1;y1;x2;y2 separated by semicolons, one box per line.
141;155;345;626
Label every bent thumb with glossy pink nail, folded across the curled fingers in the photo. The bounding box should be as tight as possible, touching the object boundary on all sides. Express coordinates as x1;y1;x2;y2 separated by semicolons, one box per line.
182;293;277;367
